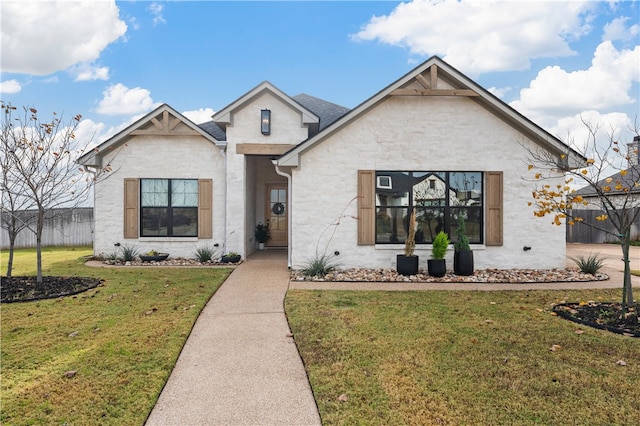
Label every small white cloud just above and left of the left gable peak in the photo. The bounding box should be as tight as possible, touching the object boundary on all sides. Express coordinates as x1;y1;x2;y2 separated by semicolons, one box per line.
97;83;158;115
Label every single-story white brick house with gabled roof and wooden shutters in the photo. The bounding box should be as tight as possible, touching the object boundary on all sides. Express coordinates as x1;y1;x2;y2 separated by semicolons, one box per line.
79;57;584;269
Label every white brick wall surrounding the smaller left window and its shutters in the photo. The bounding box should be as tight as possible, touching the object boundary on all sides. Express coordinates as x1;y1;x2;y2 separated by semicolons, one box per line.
94;136;226;258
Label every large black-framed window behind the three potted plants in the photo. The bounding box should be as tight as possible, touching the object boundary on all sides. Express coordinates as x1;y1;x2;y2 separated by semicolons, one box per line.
375;171;483;244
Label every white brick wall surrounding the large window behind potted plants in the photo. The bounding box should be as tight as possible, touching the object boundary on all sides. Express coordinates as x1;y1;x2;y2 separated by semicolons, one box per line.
292;97;565;269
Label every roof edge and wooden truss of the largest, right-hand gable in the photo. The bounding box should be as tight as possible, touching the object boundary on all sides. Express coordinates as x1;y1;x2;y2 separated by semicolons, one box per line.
278;56;586;167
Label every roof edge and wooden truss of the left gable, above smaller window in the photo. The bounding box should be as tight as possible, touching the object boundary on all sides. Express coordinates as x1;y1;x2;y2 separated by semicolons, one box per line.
77;104;225;167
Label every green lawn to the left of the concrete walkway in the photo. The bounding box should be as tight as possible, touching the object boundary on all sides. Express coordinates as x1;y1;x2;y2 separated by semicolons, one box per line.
0;248;231;425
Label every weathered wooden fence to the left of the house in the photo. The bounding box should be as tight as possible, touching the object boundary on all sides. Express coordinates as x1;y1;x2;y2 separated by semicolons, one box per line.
0;207;93;250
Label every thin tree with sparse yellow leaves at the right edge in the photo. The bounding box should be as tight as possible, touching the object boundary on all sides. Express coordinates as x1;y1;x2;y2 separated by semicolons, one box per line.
528;120;640;315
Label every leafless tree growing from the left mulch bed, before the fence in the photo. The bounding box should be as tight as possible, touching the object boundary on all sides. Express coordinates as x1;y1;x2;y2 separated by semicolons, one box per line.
0;102;110;283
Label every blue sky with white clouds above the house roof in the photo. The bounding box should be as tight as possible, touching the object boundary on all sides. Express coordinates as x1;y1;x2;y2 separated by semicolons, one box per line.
0;0;640;150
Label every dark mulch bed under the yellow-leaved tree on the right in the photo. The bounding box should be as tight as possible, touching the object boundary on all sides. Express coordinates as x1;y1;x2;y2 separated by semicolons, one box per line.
553;302;640;337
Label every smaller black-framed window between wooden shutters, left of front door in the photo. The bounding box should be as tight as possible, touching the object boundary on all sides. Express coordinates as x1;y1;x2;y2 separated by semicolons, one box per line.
140;179;198;237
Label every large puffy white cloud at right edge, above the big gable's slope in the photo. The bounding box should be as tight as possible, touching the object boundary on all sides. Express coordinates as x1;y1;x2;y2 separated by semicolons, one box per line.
511;41;640;124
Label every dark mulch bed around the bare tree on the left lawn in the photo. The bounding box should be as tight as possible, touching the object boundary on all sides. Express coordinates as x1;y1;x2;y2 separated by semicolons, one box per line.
0;276;102;303
